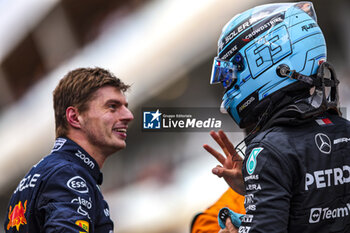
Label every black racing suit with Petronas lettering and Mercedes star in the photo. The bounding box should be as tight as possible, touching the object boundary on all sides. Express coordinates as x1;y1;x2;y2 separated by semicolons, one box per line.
239;113;350;233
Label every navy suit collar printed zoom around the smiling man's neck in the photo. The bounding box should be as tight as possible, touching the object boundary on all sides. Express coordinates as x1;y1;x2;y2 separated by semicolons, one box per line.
51;137;103;185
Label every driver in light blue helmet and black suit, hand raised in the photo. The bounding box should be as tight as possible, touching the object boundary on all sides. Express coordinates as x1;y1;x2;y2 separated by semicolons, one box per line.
206;2;350;233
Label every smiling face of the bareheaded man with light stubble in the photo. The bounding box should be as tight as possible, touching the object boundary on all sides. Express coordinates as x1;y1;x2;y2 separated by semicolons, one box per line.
79;86;134;155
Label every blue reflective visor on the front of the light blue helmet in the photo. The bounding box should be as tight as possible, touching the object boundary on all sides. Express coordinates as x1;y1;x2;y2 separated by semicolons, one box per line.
210;57;237;88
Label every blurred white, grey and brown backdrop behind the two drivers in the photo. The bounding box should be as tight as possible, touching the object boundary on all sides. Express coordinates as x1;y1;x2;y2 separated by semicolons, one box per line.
0;0;350;233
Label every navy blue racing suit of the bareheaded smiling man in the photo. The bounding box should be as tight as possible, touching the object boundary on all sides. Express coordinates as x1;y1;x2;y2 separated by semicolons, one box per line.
4;138;113;233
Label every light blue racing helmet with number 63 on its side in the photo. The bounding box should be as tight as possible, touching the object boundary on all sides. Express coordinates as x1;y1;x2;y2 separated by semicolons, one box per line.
210;2;326;128
